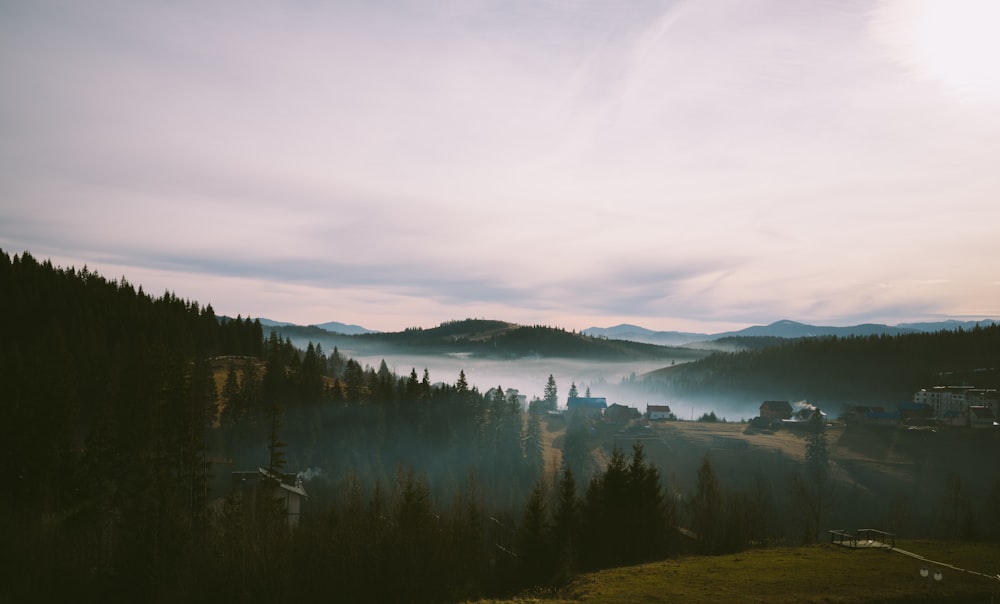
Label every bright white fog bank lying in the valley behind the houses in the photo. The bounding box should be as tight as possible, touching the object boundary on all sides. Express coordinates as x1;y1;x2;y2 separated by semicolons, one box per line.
341;349;760;421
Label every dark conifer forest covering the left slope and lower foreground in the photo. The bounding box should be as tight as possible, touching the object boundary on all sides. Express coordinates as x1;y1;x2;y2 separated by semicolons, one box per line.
0;253;673;602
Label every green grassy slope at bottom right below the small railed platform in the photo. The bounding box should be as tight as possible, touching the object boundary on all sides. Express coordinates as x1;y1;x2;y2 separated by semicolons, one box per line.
472;541;1000;604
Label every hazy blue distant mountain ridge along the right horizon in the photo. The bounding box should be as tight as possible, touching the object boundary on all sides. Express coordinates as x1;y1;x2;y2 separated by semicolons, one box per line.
582;319;996;346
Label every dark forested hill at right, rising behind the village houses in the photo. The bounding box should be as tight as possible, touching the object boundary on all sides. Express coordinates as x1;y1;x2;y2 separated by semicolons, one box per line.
639;324;1000;407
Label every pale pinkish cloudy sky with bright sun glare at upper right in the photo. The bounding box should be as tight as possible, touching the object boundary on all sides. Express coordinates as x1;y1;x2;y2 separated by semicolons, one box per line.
0;0;1000;333
